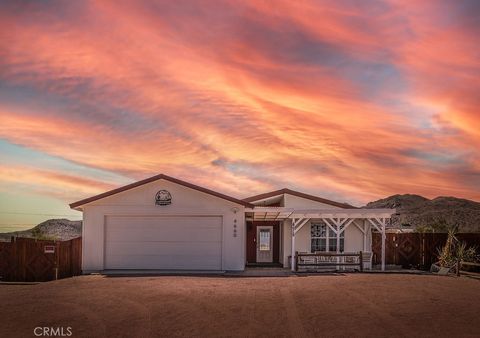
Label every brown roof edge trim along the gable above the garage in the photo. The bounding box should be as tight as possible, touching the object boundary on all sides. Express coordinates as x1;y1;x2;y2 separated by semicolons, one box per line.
70;174;253;209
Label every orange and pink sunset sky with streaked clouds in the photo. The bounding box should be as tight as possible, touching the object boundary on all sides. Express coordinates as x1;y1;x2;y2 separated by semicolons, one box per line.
0;0;480;231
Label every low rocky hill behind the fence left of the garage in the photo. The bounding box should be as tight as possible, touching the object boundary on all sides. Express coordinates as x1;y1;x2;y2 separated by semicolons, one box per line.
0;218;82;241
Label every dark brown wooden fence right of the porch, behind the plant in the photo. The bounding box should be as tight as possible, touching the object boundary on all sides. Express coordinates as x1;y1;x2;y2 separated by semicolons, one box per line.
372;233;480;270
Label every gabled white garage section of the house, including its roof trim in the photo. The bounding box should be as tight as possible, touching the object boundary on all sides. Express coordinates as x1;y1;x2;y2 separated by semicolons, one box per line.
70;174;253;274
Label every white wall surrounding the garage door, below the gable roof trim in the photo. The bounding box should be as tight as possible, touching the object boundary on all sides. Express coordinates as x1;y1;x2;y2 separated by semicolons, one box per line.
82;179;245;273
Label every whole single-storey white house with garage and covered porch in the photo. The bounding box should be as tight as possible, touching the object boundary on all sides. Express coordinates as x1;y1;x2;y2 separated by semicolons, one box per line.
70;174;394;273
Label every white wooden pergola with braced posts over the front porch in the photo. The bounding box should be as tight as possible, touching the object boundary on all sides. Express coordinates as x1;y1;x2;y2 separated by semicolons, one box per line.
245;207;396;271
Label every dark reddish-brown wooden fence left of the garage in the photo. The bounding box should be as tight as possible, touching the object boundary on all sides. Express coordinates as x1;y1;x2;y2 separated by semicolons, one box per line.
0;237;82;282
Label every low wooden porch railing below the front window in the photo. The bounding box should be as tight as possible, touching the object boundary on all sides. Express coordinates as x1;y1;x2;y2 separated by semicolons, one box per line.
295;251;363;272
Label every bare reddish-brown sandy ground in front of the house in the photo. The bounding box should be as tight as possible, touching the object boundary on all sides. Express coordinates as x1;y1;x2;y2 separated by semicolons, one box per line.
0;274;480;337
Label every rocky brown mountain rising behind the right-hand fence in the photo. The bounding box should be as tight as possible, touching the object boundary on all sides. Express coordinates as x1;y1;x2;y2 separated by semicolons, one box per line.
364;194;480;232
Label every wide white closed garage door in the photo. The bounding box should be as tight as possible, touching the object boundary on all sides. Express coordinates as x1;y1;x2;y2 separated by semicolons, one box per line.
105;216;222;270
